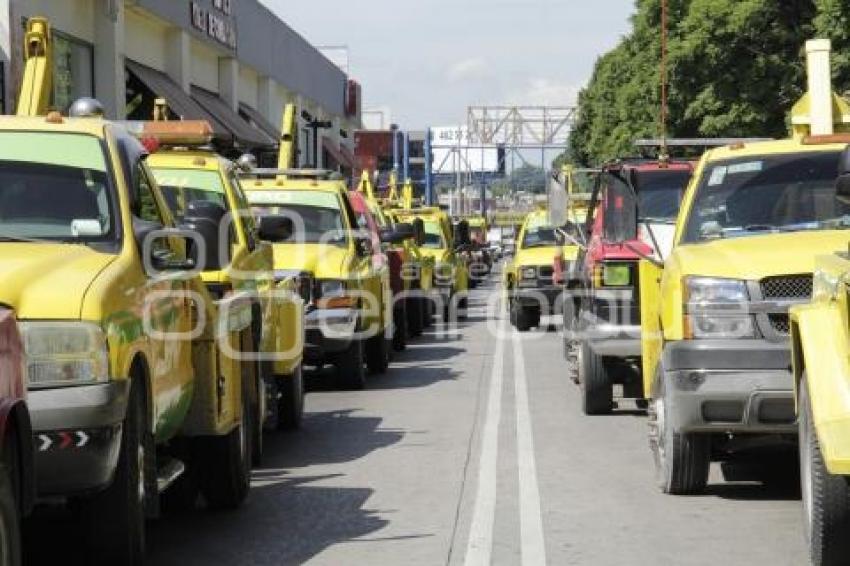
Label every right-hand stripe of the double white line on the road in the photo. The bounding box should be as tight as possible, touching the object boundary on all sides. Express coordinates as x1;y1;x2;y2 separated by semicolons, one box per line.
512;333;546;566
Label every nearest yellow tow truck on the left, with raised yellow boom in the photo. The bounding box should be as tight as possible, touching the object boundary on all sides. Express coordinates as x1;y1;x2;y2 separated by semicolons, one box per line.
9;19;256;565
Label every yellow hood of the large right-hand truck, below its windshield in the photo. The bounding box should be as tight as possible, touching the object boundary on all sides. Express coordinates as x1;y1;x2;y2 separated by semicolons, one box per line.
671;230;850;280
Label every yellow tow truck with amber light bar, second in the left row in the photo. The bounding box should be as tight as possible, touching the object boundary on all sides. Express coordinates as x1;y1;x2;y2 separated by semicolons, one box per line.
139;121;304;438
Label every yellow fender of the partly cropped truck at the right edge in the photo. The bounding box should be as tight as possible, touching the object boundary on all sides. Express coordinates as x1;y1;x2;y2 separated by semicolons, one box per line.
791;302;850;475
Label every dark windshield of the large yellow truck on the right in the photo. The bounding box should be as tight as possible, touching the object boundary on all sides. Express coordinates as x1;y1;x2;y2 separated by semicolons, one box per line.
683;152;850;243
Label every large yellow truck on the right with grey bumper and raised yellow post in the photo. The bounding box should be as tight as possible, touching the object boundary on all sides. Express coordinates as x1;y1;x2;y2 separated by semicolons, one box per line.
634;41;850;496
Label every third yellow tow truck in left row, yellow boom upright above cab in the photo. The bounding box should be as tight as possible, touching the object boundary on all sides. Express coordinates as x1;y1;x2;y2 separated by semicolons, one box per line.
239;104;393;389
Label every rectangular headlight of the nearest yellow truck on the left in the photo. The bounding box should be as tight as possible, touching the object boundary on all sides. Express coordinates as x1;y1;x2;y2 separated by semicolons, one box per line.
20;322;109;387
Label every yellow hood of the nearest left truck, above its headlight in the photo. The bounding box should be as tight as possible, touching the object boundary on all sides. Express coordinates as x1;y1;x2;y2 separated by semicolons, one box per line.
0;243;117;319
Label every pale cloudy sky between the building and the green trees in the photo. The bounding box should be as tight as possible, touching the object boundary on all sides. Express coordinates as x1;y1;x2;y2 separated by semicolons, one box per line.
261;0;634;129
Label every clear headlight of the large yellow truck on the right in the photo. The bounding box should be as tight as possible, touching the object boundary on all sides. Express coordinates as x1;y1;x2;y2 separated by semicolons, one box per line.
685;277;756;339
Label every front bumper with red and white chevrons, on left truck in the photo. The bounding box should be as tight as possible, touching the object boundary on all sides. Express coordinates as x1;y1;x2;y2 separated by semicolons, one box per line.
28;379;130;496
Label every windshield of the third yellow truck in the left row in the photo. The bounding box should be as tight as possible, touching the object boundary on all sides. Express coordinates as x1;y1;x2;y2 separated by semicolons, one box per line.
247;190;347;246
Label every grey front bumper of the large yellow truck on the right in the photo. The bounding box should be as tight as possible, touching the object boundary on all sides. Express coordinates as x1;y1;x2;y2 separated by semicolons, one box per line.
663;340;797;434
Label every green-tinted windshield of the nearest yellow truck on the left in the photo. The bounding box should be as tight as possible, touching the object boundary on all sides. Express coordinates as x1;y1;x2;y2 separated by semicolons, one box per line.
0;132;116;242
